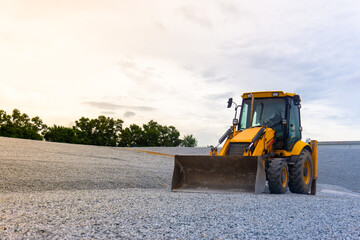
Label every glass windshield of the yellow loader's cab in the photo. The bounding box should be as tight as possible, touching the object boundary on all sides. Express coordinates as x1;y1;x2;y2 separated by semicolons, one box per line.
239;98;286;130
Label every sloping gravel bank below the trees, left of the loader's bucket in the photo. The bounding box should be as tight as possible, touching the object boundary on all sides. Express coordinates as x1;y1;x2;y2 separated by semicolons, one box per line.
0;138;173;192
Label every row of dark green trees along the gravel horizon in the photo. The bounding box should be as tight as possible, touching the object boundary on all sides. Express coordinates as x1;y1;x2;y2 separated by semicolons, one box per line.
0;109;197;147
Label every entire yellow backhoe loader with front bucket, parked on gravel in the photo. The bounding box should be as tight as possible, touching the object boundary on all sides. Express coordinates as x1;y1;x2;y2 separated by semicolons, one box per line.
171;91;317;195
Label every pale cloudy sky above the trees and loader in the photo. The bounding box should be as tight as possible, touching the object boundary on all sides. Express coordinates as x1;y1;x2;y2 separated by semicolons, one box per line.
0;0;360;146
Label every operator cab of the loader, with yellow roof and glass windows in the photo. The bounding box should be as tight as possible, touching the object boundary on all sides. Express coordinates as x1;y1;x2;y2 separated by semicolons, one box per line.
238;92;302;151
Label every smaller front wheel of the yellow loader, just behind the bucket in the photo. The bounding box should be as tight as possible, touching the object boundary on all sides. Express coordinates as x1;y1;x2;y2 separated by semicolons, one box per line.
267;159;289;194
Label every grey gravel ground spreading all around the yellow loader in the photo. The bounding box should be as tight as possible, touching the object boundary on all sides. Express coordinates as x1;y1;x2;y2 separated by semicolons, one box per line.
0;138;360;239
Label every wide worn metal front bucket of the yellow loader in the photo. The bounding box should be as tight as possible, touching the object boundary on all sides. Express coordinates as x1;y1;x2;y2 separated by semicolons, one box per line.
171;155;266;193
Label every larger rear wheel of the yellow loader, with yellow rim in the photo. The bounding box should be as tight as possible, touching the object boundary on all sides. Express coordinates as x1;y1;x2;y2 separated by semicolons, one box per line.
289;149;313;194
